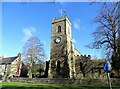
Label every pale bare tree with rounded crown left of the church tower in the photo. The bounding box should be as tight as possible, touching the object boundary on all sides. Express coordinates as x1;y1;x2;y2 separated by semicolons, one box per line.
23;37;44;78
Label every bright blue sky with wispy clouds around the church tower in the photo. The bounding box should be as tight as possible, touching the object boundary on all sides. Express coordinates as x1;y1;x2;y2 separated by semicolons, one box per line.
0;2;103;60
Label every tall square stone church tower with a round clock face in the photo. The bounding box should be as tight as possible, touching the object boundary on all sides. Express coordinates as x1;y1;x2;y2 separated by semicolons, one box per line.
49;16;74;78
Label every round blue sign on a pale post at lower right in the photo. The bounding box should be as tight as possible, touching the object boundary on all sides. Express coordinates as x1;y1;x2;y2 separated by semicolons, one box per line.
103;61;112;89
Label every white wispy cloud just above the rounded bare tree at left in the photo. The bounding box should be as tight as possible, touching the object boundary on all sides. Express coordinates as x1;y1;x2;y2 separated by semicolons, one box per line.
22;27;36;41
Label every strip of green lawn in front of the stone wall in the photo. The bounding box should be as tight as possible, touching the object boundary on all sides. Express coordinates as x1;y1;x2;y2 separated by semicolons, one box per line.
2;82;120;89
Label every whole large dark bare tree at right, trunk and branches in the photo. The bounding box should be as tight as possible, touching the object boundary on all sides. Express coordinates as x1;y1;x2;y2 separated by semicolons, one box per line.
89;2;120;76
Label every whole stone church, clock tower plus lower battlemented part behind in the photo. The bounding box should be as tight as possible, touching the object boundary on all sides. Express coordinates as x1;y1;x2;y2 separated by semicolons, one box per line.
48;16;95;78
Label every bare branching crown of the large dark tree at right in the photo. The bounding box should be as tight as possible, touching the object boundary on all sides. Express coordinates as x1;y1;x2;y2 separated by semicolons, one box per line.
87;4;120;57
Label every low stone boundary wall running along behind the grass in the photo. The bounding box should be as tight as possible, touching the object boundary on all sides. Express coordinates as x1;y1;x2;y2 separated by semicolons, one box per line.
10;78;120;85
